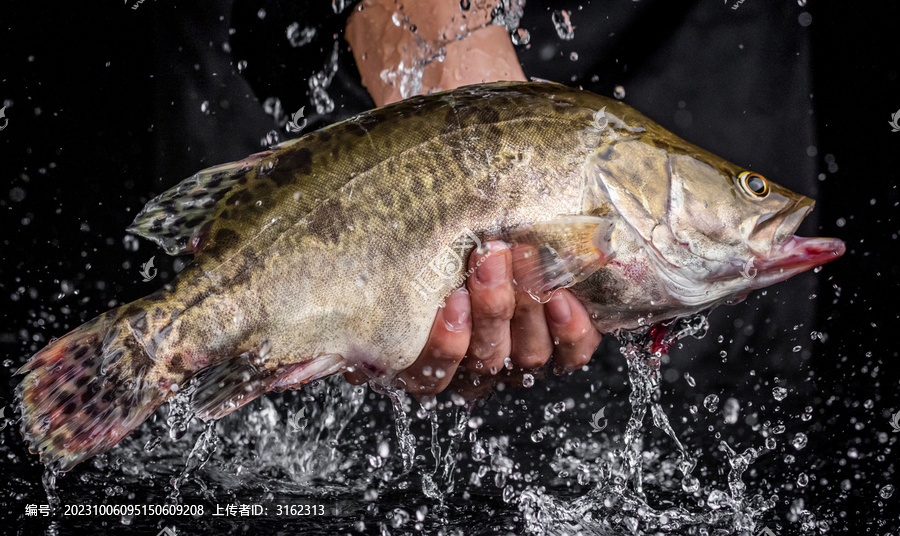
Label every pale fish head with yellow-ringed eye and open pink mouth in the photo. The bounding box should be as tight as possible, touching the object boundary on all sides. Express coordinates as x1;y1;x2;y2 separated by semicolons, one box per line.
586;116;845;310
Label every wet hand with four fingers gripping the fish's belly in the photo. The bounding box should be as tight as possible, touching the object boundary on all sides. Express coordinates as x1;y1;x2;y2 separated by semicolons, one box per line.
347;241;601;396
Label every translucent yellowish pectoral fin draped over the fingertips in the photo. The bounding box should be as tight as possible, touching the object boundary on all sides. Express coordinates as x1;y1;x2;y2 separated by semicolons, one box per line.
509;216;615;303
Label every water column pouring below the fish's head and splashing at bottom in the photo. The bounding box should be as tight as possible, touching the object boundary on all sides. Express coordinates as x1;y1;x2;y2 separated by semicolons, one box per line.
518;315;774;534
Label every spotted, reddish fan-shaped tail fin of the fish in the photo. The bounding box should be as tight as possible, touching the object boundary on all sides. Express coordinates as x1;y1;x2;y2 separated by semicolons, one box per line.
16;302;180;471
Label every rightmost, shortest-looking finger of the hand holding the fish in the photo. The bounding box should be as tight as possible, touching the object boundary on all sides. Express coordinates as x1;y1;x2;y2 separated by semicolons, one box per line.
546;289;600;372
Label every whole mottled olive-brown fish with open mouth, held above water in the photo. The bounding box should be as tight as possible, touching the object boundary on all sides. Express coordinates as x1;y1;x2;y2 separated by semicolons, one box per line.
16;82;845;471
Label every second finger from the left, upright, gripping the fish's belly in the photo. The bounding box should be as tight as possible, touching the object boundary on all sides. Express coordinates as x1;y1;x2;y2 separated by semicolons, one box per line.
465;242;516;373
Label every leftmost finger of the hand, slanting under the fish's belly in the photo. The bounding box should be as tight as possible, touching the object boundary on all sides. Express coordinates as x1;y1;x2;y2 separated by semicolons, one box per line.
400;288;472;396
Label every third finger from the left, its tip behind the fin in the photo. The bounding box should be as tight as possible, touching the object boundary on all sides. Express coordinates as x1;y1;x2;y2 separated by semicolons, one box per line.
510;245;553;369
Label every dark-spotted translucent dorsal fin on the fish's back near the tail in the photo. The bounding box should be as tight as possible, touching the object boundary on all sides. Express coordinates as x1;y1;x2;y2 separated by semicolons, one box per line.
127;138;299;255
